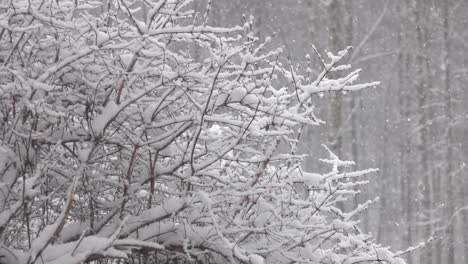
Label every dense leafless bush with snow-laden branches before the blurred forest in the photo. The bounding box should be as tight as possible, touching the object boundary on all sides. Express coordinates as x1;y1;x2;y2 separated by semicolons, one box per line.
0;0;403;264
